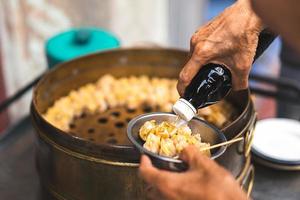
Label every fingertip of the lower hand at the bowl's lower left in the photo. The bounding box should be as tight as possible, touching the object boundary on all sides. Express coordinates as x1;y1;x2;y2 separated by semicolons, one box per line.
139;155;172;187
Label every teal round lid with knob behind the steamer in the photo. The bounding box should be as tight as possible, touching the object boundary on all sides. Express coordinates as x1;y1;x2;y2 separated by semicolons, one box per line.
45;28;120;68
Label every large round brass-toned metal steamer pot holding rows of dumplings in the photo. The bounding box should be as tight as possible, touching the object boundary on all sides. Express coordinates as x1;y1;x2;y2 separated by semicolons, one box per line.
31;48;256;199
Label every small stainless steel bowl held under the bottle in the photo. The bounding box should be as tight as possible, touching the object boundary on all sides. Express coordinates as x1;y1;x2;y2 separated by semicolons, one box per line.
127;112;226;171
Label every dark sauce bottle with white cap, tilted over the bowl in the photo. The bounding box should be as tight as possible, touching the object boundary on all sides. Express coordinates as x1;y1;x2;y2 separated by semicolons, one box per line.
173;30;276;121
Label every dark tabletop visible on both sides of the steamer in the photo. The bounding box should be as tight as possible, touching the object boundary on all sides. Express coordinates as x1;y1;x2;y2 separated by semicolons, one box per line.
0;115;300;200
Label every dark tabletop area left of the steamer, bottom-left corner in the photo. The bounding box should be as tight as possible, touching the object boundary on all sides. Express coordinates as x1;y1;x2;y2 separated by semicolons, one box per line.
0;118;40;200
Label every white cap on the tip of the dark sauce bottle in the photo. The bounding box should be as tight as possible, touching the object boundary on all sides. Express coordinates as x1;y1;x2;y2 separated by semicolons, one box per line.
173;98;197;121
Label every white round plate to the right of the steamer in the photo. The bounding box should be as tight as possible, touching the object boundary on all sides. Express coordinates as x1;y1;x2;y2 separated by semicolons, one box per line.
252;118;300;165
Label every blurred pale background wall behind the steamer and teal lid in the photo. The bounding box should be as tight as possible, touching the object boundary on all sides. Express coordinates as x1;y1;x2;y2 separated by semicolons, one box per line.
0;0;280;130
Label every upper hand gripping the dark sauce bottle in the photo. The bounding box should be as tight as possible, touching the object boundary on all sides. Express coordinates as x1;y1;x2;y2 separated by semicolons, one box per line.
177;0;263;96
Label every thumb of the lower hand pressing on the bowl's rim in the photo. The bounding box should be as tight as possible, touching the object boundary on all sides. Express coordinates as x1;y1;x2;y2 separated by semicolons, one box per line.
180;146;212;169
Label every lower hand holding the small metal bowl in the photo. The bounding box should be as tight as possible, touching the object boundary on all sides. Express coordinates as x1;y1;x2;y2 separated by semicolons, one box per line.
139;146;247;200
